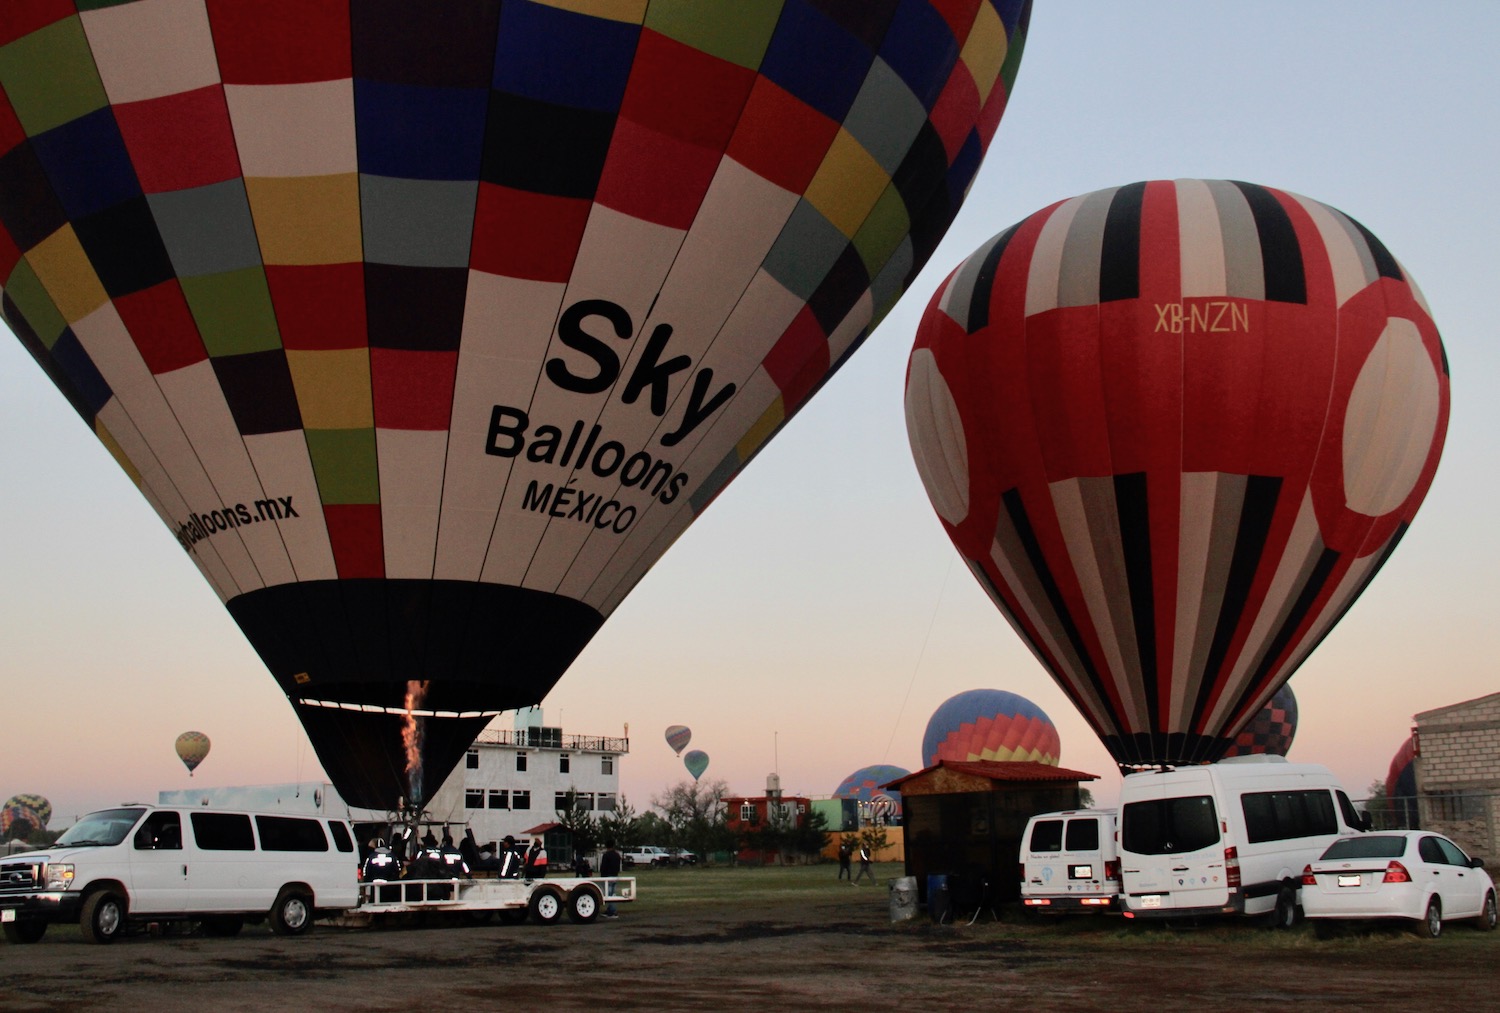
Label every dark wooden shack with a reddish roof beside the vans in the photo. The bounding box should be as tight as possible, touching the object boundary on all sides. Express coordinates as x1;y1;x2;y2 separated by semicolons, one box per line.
887;759;1098;903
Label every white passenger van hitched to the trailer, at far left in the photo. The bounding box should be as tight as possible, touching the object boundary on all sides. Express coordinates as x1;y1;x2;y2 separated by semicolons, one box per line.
0;804;359;942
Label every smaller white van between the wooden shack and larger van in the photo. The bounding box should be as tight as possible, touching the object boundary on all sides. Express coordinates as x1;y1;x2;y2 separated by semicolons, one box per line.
1020;809;1121;914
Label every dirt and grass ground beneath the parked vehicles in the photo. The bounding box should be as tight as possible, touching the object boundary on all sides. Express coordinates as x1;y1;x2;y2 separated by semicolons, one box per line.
0;866;1500;1013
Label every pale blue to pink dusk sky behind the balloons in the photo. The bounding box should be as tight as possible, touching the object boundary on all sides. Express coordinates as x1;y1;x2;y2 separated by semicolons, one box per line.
0;0;1500;825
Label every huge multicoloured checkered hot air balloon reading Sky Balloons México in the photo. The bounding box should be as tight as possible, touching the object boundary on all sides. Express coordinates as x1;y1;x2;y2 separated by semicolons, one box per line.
0;0;1031;807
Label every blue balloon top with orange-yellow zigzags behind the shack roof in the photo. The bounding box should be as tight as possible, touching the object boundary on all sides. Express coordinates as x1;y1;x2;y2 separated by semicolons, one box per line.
923;689;1062;767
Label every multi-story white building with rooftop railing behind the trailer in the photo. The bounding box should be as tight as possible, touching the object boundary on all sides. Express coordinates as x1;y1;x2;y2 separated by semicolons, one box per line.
428;707;630;843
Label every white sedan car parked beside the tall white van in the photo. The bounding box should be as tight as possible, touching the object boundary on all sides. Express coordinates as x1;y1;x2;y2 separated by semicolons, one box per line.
1302;830;1496;939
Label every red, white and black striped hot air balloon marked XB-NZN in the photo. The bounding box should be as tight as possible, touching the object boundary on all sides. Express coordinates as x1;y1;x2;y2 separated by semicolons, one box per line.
906;180;1449;767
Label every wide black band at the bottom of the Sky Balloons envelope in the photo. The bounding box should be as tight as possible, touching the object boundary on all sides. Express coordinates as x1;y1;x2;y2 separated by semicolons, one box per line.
228;579;605;711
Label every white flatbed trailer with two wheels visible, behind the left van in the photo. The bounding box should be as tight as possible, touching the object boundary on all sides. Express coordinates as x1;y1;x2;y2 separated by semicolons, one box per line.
330;876;636;927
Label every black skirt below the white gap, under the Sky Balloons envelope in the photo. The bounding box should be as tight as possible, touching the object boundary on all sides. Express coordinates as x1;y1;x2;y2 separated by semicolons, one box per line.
293;702;489;809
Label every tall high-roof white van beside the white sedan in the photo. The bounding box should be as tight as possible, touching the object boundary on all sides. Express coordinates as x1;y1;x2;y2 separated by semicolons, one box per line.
1121;753;1368;927
